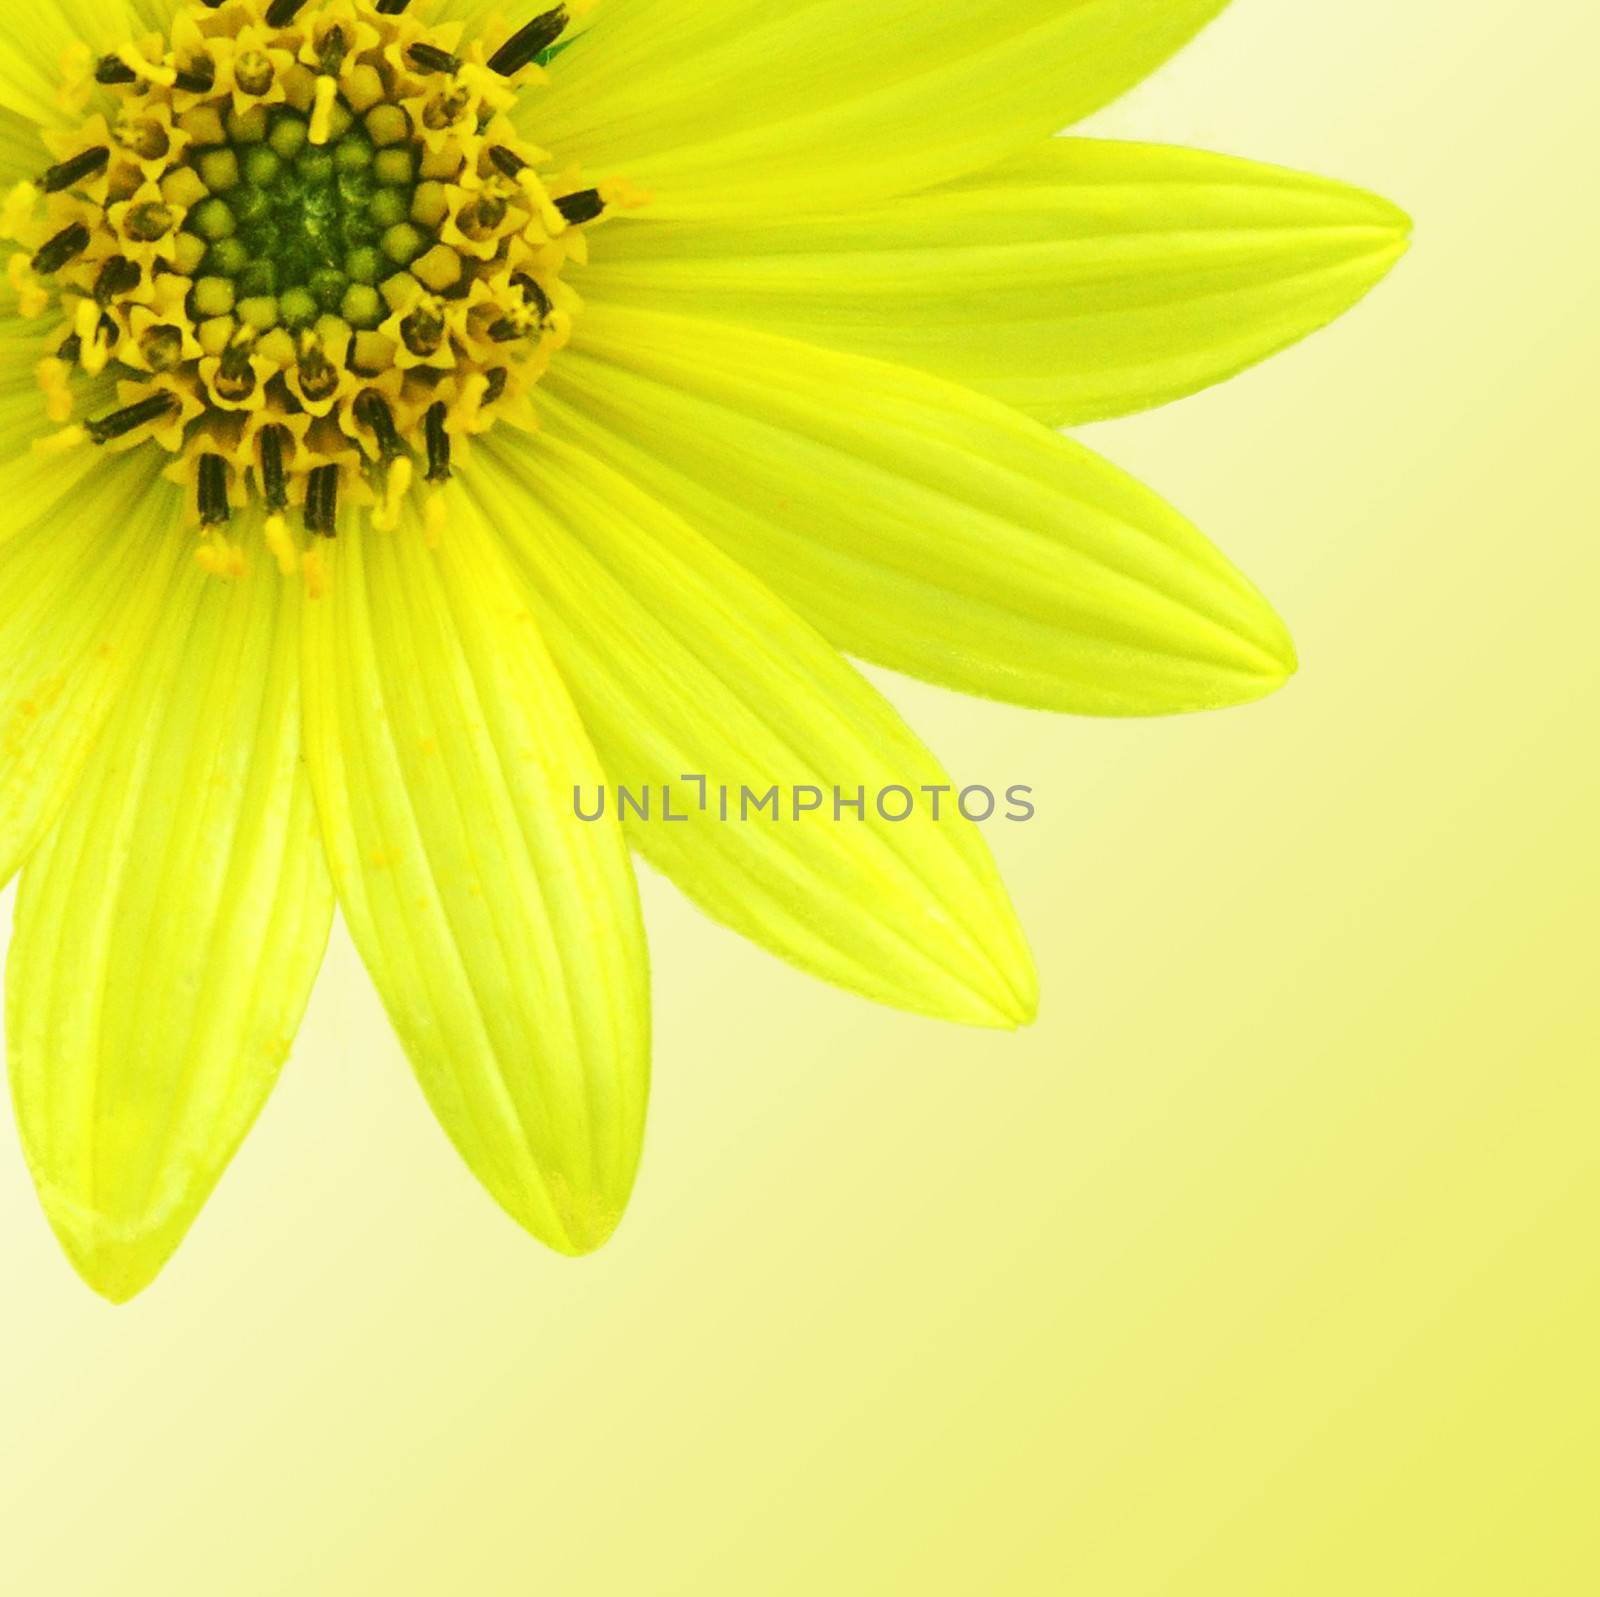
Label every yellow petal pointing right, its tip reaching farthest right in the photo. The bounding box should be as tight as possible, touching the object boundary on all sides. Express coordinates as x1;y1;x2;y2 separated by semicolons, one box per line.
578;139;1410;426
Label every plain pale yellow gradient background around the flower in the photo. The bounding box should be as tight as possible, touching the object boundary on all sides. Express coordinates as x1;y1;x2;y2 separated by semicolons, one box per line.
0;0;1600;1597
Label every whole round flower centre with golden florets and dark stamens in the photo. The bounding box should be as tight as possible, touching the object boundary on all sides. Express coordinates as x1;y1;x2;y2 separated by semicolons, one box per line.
0;0;621;571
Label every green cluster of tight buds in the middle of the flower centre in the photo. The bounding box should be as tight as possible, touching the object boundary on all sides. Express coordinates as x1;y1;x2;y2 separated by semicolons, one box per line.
184;101;432;331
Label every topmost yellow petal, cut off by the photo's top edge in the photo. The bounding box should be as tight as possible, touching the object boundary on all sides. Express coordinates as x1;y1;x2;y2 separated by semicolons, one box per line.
525;0;1224;216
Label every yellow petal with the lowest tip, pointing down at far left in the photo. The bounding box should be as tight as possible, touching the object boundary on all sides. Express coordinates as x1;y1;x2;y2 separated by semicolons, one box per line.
6;539;333;1301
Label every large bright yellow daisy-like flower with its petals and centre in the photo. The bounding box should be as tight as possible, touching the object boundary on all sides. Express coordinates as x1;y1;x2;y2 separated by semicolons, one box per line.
0;0;1406;1299
